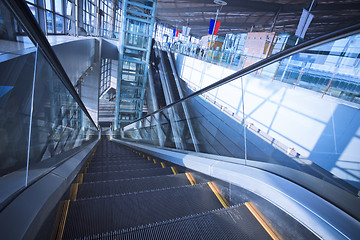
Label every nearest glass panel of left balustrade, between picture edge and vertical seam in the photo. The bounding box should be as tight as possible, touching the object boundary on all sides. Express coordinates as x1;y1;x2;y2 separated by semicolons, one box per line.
0;2;35;203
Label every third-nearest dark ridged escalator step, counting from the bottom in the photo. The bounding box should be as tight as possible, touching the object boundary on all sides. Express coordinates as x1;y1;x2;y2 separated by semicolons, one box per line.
77;174;190;199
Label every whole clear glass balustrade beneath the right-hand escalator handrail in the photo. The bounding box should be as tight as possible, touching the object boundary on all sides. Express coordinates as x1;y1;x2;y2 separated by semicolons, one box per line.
115;30;360;196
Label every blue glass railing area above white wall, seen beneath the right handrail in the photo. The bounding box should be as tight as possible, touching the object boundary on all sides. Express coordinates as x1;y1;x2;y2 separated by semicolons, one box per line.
274;35;360;103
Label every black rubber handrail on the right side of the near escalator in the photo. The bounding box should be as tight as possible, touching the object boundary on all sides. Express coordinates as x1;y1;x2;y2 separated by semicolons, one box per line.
128;24;360;125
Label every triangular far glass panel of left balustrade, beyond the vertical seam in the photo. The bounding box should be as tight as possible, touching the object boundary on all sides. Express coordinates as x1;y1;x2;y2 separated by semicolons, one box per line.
29;47;97;181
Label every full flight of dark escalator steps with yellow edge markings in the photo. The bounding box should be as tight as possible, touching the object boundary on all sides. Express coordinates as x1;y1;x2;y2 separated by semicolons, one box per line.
53;139;300;239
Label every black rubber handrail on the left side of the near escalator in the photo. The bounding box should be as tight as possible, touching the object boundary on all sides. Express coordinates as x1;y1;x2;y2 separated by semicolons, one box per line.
2;0;99;130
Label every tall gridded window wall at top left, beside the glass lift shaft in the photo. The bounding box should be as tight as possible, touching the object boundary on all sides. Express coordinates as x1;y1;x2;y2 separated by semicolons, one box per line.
26;0;121;39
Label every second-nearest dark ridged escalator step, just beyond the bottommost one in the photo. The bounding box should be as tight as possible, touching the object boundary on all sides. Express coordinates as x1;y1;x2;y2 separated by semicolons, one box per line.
64;184;221;239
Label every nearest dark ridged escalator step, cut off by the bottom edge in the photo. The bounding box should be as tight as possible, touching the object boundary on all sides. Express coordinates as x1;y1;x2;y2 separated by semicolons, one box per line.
116;205;272;240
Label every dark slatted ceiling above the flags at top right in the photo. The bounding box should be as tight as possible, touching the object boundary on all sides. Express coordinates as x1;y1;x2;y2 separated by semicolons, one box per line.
156;0;360;39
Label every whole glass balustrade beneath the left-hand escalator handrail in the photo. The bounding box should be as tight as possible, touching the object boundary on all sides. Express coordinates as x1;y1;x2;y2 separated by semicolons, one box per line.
0;2;98;208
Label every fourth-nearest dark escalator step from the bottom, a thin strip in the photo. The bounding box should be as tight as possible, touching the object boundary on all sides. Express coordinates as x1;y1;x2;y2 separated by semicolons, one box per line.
87;161;161;173
